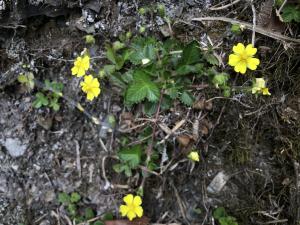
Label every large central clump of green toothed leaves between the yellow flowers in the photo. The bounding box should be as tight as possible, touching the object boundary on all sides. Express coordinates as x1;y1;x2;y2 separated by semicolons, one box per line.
101;37;230;111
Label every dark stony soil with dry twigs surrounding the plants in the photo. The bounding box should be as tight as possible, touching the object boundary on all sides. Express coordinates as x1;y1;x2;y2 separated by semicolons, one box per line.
0;0;300;225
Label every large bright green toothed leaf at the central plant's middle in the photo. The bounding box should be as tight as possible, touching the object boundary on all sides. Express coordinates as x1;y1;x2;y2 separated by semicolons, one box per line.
125;70;160;105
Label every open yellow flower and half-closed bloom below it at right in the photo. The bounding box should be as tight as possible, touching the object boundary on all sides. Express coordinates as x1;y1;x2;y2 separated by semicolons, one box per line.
228;43;271;95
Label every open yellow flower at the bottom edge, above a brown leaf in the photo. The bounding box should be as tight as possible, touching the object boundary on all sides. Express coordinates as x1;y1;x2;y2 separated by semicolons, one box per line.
120;194;143;221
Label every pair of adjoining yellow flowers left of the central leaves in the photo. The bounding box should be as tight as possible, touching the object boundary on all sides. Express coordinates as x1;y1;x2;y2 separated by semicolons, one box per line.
71;55;101;101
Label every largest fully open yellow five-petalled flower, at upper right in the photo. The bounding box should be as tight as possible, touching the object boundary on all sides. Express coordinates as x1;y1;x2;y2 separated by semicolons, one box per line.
228;43;260;74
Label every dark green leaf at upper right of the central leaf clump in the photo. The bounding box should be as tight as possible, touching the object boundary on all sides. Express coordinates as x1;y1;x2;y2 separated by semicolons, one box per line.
179;41;202;65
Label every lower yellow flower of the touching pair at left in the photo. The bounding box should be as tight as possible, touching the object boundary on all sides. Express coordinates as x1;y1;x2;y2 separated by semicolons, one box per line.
80;75;101;101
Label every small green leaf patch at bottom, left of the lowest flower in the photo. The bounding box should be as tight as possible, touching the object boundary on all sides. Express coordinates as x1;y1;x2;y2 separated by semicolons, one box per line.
58;192;113;225
